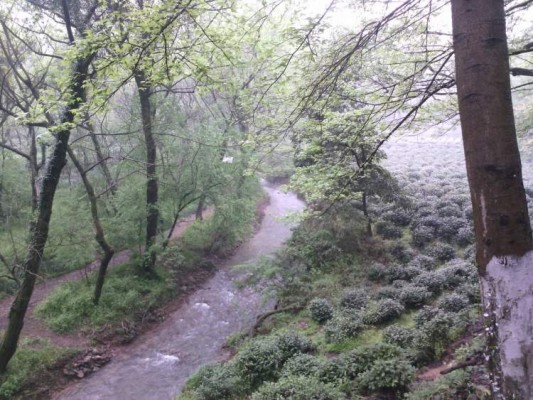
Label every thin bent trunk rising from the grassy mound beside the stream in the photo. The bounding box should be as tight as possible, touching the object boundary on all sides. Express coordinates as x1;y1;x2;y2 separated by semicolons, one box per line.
67;147;115;305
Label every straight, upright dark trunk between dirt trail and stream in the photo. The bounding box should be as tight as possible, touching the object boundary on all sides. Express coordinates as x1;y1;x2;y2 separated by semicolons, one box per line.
135;71;159;273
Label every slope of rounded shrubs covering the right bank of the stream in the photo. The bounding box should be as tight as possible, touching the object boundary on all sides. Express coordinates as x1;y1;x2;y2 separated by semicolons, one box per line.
179;138;533;400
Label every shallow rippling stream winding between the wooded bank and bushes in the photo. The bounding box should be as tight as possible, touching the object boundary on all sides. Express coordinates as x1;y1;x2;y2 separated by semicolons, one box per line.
54;186;304;400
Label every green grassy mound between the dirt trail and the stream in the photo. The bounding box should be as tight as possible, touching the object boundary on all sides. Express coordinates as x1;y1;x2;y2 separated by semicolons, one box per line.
35;264;174;333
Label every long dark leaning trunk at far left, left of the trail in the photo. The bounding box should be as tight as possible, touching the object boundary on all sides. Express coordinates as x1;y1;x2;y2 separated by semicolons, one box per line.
0;56;92;373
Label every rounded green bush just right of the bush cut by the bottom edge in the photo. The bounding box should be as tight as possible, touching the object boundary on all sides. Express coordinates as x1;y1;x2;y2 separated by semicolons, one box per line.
358;359;415;396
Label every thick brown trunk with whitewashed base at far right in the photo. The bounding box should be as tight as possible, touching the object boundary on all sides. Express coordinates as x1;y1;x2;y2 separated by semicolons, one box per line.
452;0;533;400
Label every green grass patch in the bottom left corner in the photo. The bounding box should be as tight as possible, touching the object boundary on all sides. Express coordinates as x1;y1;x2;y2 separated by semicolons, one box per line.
0;338;78;400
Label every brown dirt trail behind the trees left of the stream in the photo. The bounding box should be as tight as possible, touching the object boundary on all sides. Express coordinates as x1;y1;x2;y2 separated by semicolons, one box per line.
0;209;213;347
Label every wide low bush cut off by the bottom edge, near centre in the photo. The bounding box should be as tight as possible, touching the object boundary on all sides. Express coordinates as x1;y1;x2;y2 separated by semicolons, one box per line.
252;376;346;400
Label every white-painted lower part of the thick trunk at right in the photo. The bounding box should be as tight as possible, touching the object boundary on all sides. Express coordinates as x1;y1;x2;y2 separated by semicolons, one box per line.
481;252;533;400
